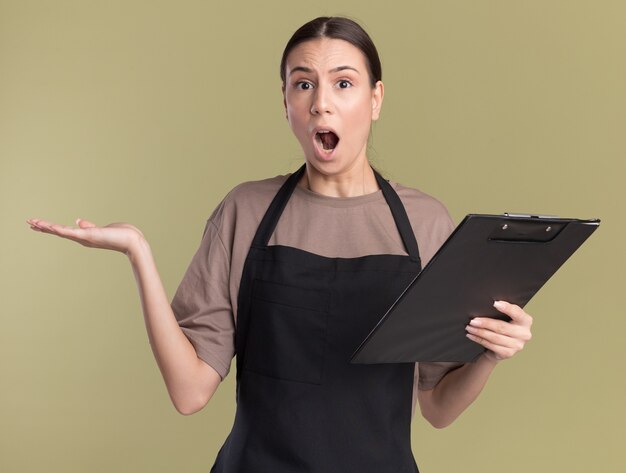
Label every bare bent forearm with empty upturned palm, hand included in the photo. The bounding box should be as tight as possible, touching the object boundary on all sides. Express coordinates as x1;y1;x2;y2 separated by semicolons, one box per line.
27;219;221;415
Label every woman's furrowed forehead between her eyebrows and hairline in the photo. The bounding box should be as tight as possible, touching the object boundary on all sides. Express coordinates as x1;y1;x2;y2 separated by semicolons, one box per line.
286;38;366;74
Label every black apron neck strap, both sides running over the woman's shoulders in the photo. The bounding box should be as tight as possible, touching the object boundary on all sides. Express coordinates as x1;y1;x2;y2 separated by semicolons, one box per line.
252;164;420;262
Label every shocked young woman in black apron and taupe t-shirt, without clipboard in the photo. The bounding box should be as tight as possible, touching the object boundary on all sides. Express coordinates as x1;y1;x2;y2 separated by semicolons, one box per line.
28;17;532;473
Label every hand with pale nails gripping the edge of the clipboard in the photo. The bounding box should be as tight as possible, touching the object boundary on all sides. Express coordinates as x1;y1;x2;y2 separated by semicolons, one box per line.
466;301;533;362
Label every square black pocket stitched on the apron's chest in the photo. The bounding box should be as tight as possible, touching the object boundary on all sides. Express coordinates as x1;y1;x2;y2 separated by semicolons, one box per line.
244;279;329;384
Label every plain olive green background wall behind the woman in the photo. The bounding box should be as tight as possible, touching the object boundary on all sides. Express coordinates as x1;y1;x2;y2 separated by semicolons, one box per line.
0;0;626;473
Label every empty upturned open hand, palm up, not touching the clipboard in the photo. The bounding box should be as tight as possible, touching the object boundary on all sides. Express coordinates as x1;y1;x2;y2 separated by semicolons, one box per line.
26;218;145;255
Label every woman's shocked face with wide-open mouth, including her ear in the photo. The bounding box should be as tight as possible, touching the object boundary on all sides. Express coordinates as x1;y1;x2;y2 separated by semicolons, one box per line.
283;38;383;176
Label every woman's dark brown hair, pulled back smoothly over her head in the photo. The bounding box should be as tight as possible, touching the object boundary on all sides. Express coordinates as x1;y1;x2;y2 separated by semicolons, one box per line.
280;16;382;87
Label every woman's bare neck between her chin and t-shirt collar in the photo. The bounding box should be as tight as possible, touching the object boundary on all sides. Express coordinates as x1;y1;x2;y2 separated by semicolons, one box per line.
300;161;379;197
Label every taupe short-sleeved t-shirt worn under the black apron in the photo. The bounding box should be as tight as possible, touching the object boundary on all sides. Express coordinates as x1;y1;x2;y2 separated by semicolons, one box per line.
171;176;459;407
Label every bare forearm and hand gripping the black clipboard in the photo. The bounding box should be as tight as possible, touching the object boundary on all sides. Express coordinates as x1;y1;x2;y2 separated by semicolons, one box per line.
417;302;532;428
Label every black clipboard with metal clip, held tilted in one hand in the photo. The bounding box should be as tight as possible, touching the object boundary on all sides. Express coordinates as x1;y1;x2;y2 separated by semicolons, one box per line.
351;214;600;364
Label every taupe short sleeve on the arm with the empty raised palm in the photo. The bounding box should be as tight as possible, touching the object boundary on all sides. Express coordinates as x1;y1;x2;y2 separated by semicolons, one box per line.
171;219;235;380
